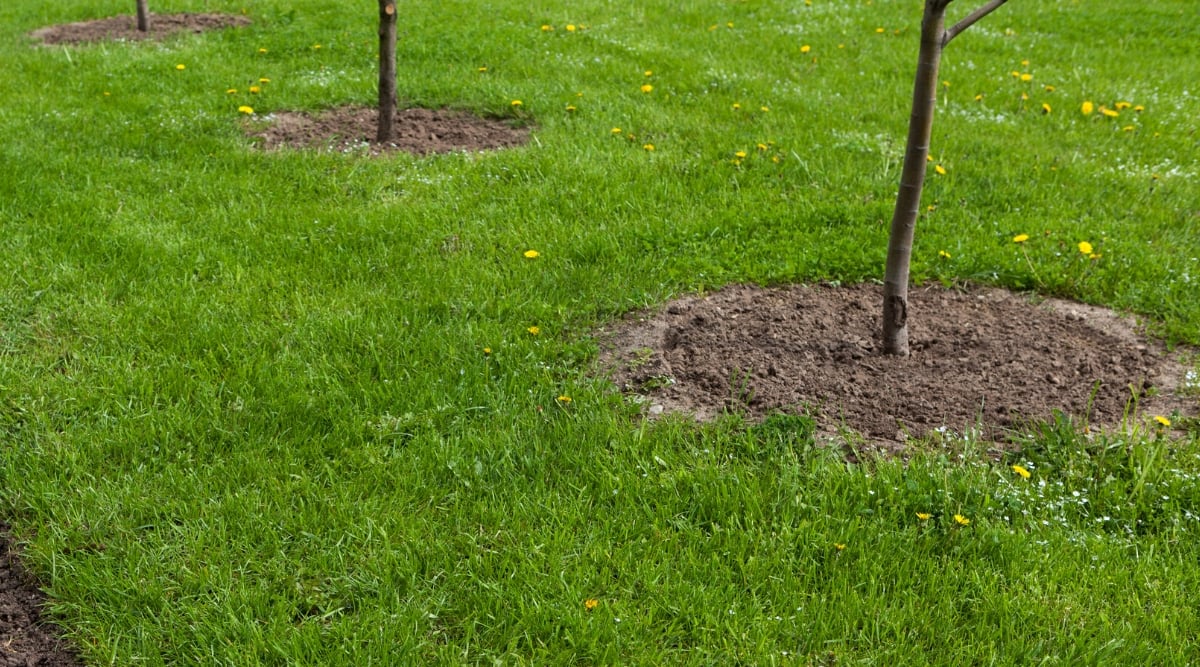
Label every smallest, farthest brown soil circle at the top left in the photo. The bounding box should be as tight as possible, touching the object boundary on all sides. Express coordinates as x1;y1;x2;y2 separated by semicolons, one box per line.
29;13;250;44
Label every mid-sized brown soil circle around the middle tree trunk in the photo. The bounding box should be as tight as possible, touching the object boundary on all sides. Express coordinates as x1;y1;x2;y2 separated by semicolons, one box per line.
247;107;529;155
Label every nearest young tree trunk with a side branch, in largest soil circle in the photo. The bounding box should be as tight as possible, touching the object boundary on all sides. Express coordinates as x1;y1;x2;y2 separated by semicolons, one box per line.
883;0;1007;356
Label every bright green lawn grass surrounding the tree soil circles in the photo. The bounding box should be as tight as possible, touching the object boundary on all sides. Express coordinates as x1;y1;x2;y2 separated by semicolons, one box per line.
0;0;1200;665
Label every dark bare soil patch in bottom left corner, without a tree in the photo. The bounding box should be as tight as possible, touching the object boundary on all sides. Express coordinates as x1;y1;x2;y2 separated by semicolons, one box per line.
0;524;83;667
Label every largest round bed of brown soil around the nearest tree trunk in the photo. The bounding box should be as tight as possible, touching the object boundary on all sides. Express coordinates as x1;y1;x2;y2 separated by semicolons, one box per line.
601;284;1200;453
